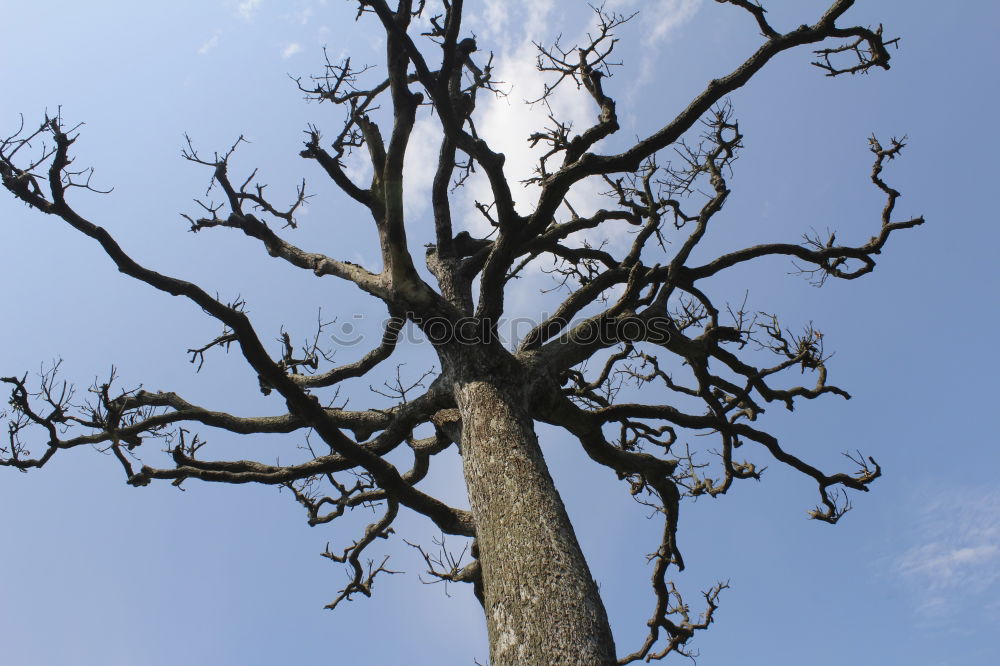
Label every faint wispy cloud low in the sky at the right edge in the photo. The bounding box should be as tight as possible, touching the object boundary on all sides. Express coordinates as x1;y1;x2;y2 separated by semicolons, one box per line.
894;489;1000;617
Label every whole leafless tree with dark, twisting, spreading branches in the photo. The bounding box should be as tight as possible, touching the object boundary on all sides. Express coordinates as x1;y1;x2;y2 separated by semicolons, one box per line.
0;0;923;666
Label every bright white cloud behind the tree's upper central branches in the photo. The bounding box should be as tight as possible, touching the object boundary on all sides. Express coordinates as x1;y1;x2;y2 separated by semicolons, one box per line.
398;0;688;313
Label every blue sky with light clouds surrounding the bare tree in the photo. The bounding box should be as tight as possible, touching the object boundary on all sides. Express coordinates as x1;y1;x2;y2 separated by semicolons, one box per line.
0;0;1000;666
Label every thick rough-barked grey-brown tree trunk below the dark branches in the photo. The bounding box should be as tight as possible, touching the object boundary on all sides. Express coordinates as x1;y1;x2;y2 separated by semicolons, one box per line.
456;381;616;666
